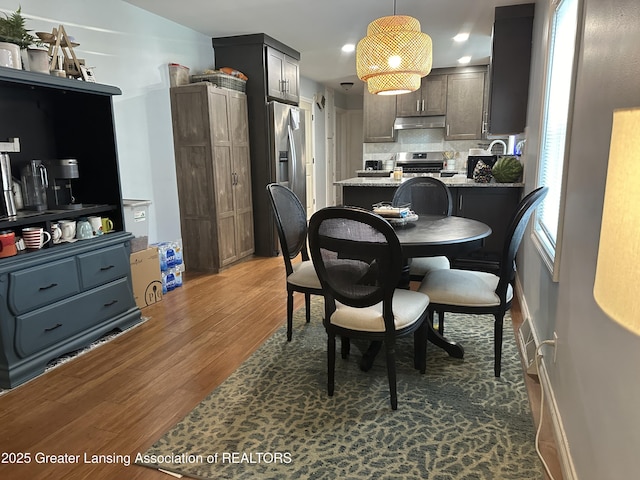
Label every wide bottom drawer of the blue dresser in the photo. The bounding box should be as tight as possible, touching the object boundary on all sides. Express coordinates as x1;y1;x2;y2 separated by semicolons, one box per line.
15;278;135;358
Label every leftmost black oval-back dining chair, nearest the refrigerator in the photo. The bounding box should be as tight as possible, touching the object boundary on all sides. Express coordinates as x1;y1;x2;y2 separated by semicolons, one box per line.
266;183;322;341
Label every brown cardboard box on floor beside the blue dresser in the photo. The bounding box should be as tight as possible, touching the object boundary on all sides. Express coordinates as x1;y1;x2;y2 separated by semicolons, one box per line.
130;247;162;308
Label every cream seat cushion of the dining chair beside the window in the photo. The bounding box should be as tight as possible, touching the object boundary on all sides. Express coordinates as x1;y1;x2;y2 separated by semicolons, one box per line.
418;269;513;307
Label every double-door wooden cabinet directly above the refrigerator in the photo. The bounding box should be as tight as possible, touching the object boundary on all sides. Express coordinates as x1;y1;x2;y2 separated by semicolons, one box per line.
266;46;300;105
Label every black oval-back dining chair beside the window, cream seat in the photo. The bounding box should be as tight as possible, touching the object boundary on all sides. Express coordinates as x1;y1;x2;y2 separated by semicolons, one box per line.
418;187;548;377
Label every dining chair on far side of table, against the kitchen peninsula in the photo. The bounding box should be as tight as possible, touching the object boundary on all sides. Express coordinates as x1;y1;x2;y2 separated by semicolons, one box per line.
391;177;453;281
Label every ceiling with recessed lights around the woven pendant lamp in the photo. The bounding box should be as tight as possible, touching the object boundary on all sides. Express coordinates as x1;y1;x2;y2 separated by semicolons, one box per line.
125;0;533;94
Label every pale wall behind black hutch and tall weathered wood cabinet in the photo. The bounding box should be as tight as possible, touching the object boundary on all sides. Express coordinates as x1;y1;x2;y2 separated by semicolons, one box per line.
0;0;213;242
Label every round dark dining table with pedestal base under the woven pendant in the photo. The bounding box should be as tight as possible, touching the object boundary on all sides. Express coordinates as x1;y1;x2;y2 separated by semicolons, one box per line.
360;215;491;371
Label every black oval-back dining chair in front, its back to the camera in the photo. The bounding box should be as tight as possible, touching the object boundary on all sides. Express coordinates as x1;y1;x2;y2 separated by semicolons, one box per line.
309;207;429;410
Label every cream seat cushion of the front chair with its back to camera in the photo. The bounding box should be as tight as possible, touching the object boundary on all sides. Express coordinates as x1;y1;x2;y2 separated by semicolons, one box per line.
331;289;429;332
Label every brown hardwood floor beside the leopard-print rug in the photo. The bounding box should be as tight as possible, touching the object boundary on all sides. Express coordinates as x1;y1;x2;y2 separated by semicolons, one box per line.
0;258;561;480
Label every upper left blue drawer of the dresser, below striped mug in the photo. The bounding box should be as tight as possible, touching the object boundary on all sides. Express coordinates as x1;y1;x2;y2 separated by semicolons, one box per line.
8;257;80;315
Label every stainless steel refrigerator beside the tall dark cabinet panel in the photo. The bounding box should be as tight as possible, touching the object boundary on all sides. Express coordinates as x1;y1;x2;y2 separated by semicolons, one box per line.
268;102;307;253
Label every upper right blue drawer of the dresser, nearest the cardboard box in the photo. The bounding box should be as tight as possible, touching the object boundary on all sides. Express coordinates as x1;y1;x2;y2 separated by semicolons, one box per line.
77;244;130;289
